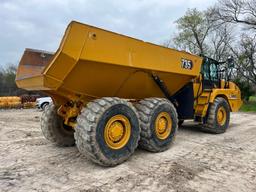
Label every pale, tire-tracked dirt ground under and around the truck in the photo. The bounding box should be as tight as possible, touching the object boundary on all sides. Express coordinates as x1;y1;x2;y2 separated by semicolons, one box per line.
0;109;256;192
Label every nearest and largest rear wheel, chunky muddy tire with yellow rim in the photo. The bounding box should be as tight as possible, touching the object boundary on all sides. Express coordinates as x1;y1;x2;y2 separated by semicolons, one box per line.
75;97;140;166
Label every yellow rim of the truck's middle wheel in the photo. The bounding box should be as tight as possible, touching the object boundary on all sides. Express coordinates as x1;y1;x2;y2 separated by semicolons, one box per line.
155;112;172;140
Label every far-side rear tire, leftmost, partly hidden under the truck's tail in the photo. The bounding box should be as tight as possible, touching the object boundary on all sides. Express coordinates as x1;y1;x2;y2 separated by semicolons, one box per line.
41;104;75;146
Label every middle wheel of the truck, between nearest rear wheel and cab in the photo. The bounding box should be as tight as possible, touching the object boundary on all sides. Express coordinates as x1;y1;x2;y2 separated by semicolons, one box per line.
136;98;178;152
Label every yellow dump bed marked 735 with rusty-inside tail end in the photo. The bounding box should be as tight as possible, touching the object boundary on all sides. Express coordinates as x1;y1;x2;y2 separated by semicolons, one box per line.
16;21;202;100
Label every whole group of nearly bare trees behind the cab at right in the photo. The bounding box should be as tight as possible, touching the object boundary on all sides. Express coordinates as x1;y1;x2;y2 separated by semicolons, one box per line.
164;0;256;100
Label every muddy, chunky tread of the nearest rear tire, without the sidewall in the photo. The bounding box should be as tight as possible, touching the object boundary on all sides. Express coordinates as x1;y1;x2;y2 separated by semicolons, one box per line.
75;97;138;166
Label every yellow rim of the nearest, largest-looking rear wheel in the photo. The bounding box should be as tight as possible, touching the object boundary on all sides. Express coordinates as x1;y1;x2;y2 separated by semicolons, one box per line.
104;115;131;149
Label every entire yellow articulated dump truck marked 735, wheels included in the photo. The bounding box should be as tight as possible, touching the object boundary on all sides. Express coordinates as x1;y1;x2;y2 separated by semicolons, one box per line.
16;21;242;166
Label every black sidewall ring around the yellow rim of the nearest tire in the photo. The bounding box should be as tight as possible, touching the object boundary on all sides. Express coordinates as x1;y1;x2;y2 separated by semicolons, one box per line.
96;104;140;160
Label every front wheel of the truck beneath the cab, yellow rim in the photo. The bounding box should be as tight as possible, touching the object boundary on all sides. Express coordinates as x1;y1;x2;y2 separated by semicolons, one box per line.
201;97;230;134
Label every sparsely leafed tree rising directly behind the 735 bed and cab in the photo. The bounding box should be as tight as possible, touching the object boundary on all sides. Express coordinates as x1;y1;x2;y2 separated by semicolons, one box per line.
171;9;232;60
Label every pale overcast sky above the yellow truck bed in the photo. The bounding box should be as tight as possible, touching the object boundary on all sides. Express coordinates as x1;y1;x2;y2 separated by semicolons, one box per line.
0;0;216;66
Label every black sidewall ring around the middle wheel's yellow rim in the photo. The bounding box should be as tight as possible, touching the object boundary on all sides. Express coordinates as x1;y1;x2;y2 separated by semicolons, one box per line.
150;104;178;148
